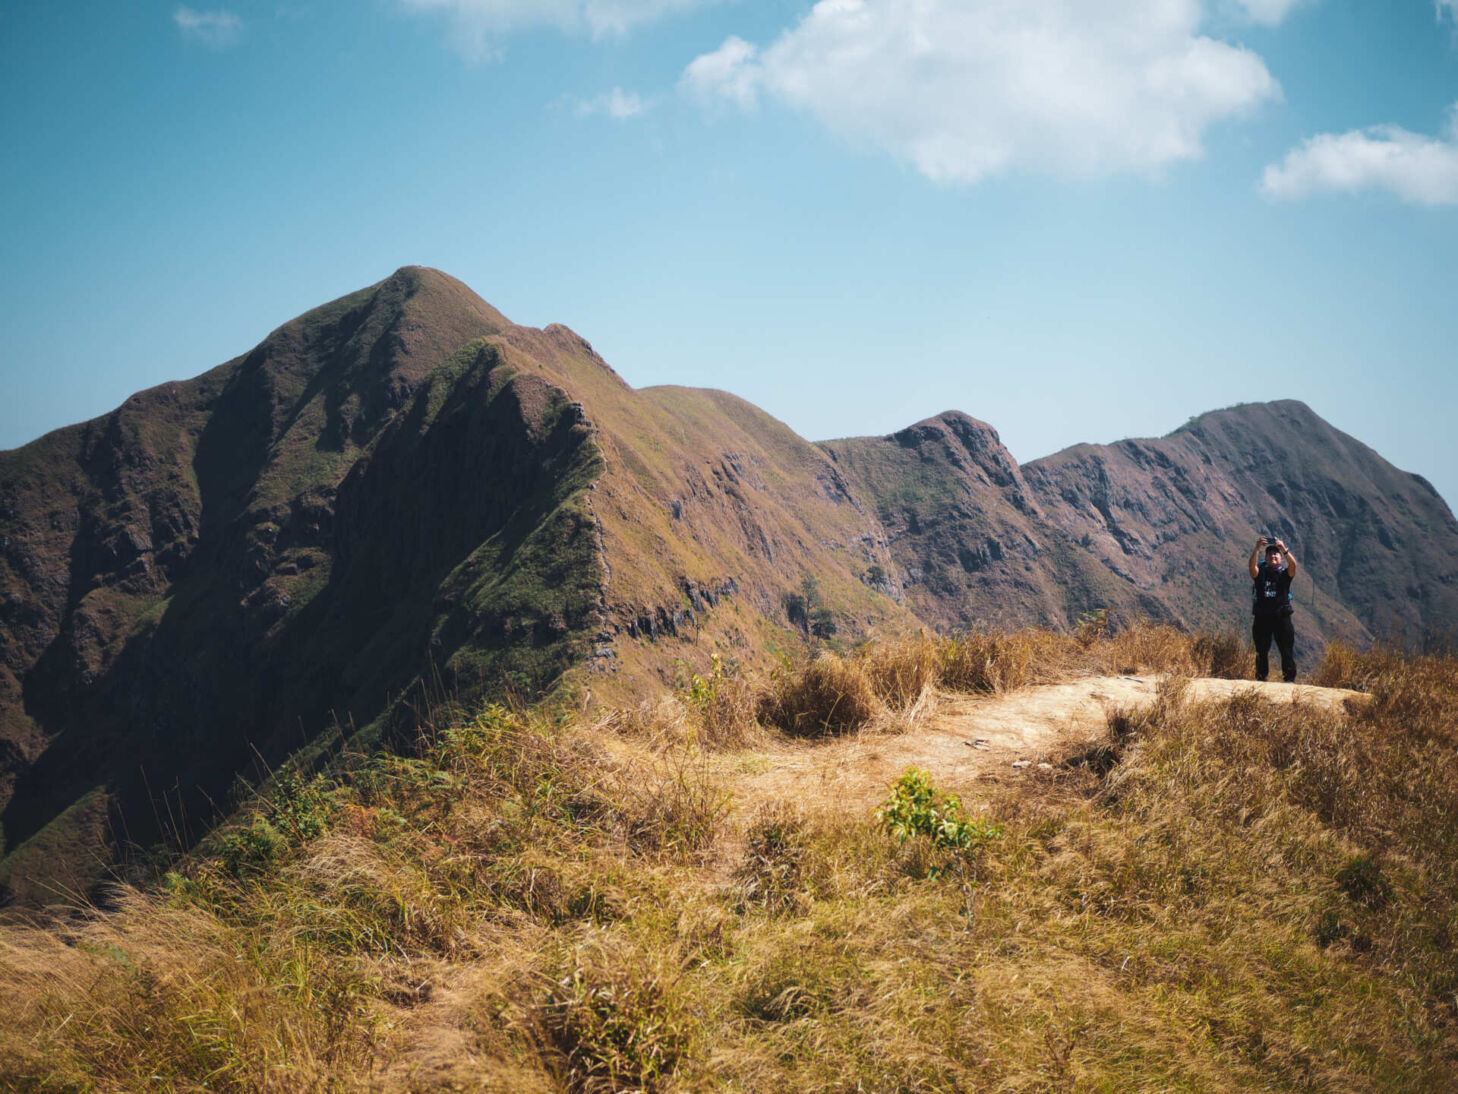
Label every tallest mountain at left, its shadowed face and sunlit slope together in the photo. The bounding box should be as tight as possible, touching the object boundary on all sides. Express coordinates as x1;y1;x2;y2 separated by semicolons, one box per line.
0;268;911;904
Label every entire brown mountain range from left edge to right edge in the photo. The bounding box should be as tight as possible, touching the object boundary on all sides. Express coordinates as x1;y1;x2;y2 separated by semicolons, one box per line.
0;267;1458;899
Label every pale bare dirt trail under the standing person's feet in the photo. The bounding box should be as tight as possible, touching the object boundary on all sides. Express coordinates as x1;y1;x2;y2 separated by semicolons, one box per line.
730;675;1365;815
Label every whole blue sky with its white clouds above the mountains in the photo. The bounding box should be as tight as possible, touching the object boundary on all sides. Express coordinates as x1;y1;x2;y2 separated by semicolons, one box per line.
0;0;1458;513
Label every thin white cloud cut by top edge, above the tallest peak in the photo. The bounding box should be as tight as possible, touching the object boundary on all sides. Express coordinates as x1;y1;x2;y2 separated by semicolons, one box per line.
399;0;713;58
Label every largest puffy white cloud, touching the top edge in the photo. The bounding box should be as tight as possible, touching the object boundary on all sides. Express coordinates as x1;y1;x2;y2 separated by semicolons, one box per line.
679;0;1280;182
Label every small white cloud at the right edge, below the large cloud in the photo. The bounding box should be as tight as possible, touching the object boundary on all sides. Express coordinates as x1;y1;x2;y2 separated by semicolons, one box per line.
1261;105;1458;206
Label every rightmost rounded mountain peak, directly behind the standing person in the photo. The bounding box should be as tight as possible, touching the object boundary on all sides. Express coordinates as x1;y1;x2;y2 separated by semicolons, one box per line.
1024;400;1458;645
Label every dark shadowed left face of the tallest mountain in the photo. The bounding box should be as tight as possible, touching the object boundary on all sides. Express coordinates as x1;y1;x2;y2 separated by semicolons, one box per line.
0;270;599;898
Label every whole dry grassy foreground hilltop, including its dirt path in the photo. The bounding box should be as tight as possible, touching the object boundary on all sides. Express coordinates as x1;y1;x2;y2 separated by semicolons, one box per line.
0;626;1458;1094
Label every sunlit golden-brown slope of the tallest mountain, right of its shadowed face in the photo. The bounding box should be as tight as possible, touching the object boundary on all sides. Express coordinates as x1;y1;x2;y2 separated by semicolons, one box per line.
478;316;914;699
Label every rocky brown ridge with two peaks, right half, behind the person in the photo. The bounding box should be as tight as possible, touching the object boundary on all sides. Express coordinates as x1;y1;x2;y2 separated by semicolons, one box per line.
822;401;1458;646
